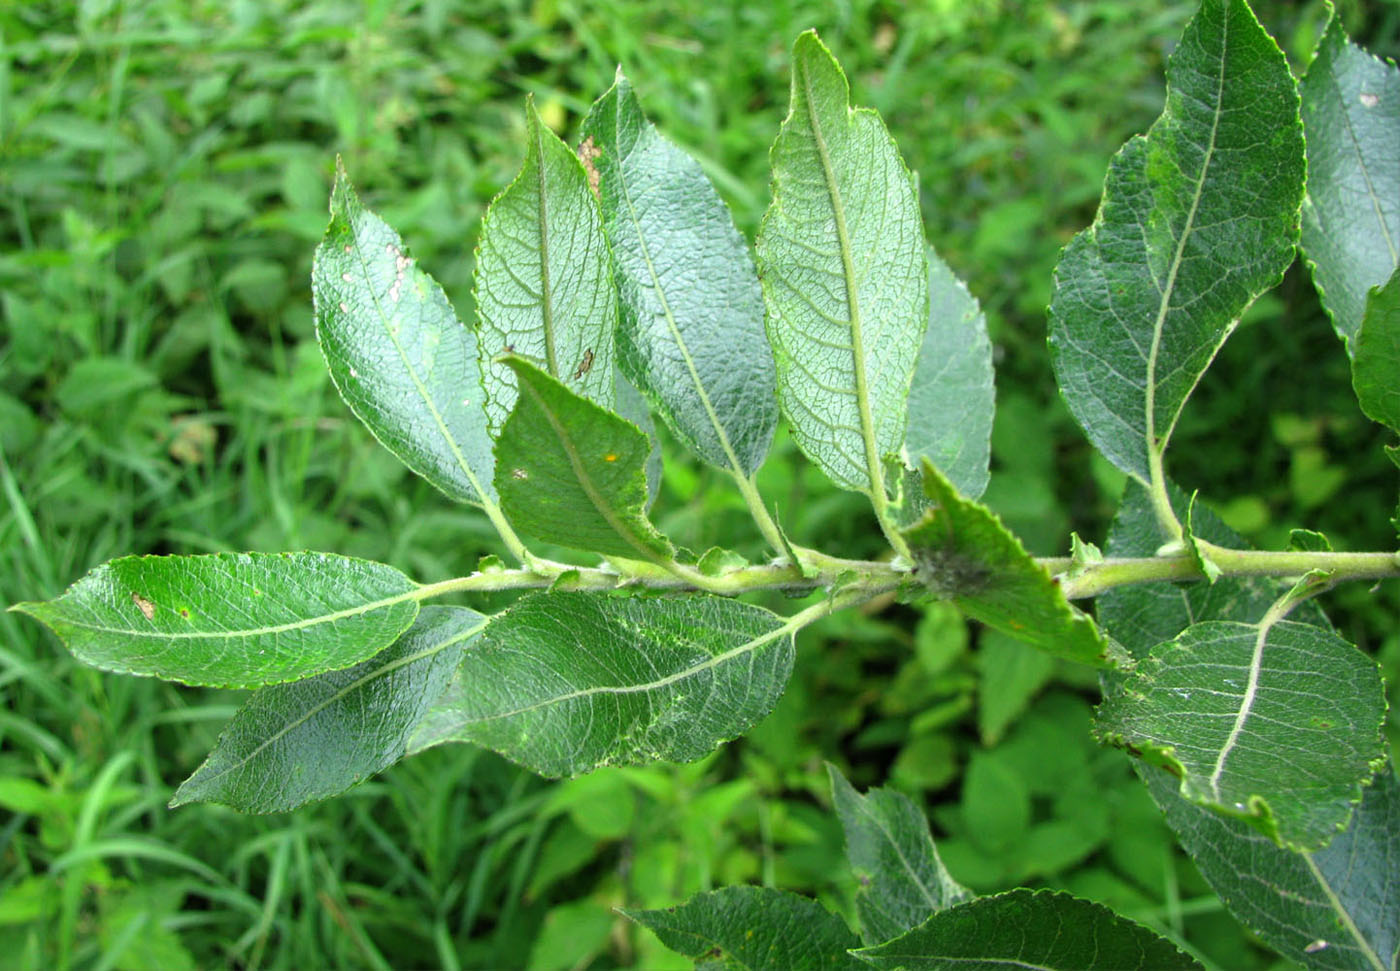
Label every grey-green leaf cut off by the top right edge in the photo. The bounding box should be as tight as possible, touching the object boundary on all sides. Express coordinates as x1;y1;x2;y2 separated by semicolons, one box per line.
1298;14;1400;346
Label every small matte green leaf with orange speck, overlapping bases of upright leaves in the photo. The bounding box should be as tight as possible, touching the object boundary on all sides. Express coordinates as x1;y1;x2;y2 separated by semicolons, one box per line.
496;355;672;561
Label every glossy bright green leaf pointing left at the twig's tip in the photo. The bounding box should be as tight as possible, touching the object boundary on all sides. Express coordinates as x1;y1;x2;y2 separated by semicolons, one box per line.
11;553;419;688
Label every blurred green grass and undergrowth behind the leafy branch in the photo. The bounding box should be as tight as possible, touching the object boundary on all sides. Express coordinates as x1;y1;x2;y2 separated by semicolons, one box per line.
0;0;1400;971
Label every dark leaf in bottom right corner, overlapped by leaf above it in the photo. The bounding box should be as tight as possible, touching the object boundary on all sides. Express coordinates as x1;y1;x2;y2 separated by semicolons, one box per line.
1138;767;1400;971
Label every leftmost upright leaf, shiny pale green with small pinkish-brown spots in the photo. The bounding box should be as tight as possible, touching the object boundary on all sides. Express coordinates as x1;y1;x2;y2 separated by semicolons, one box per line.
311;162;496;504
